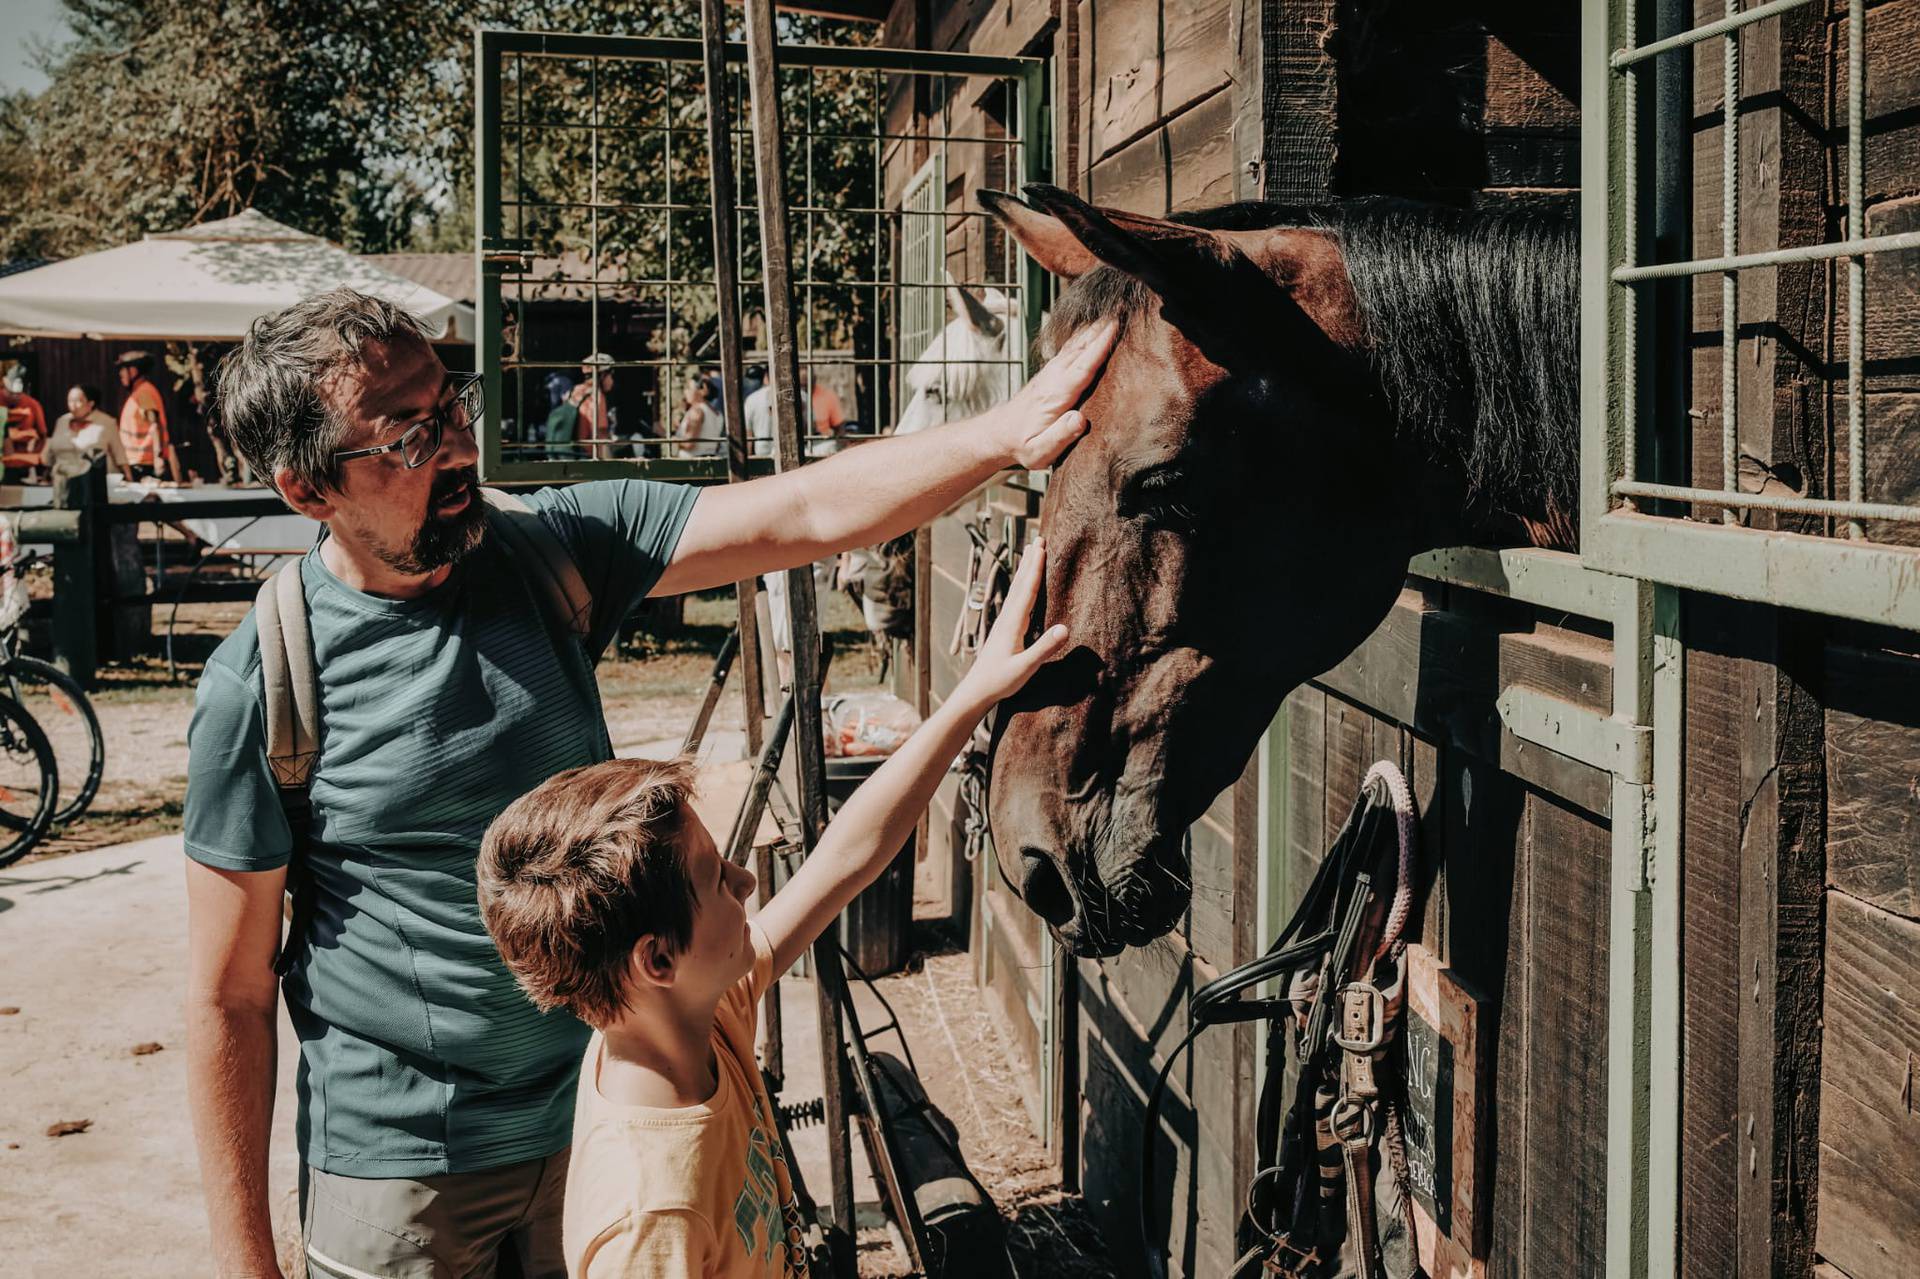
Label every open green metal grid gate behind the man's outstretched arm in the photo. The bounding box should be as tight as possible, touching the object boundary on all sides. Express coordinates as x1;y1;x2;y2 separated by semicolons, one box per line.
476;31;1048;482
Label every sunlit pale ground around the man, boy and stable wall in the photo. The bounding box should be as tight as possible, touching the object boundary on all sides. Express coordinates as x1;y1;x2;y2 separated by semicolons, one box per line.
0;593;1112;1279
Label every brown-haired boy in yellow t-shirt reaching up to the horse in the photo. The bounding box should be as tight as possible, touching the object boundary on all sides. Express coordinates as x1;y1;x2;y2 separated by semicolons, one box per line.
480;542;1068;1279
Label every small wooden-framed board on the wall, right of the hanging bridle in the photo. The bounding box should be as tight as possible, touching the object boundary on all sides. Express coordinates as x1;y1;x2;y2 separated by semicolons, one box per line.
1404;945;1494;1279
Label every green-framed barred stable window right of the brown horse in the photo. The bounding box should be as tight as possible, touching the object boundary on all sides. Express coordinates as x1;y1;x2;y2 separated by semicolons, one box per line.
1580;0;1920;628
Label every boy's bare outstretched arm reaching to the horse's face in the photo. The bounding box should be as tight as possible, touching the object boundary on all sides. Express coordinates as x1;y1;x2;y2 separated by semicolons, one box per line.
758;542;1068;976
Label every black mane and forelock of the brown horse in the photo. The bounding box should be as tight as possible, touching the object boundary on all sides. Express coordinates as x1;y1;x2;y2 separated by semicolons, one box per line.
1048;198;1580;530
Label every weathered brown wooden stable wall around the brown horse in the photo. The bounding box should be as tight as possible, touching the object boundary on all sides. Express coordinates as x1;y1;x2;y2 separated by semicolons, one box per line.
891;0;1920;1279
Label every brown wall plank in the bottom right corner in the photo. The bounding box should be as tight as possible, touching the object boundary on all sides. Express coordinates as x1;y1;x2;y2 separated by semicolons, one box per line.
1816;893;1920;1279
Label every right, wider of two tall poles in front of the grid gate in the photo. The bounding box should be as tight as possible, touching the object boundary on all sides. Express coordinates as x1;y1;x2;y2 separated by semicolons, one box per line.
747;0;854;1279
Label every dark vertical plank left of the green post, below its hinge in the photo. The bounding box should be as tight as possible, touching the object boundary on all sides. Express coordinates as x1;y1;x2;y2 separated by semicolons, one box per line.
1507;795;1611;1275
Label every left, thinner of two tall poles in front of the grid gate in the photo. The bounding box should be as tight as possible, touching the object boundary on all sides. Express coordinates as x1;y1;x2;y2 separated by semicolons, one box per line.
702;0;766;755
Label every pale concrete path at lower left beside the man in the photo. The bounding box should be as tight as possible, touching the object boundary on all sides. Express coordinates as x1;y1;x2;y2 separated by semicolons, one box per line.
0;835;298;1277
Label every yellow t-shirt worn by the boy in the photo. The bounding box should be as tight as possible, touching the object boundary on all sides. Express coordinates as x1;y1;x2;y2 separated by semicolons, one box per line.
563;924;806;1279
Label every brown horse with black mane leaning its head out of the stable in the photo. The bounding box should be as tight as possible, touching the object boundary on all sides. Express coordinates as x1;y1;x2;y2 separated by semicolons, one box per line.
981;186;1578;956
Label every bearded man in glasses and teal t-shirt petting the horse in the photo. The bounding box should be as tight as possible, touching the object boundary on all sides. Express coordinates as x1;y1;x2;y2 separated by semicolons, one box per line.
184;290;1112;1277
